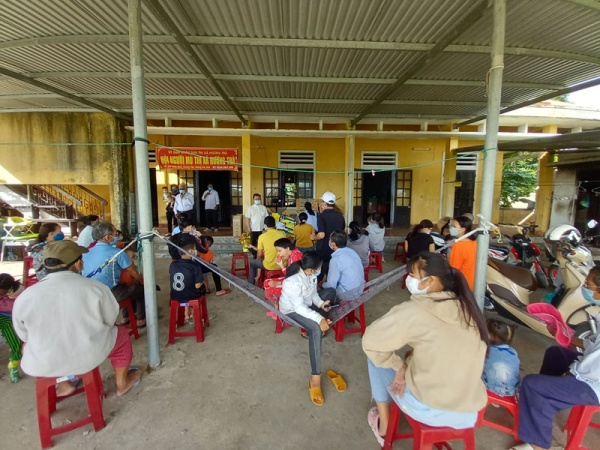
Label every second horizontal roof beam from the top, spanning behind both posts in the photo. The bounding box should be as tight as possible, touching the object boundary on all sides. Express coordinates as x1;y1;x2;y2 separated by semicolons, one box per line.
5;72;565;91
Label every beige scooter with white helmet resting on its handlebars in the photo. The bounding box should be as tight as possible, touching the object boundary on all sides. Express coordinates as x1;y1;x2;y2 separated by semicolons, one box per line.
486;221;600;338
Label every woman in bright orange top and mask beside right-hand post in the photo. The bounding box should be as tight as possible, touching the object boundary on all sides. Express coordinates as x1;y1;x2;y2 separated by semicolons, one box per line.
448;216;477;290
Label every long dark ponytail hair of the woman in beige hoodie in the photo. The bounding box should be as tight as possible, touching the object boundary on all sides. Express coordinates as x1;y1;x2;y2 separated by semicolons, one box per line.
406;252;490;345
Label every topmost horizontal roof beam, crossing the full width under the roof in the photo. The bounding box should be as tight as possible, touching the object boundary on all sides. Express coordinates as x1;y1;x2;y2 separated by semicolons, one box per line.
0;34;600;64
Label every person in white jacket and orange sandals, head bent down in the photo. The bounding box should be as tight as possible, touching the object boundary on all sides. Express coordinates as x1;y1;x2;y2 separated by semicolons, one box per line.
279;251;331;406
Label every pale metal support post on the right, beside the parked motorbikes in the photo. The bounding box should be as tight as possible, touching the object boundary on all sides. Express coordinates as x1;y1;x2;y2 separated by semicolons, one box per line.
474;0;506;308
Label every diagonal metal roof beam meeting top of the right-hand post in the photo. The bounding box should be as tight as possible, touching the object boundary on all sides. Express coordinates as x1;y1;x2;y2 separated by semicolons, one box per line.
350;0;489;127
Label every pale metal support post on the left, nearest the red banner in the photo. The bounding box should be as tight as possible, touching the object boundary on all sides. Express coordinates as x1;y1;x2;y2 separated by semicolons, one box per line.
127;0;160;367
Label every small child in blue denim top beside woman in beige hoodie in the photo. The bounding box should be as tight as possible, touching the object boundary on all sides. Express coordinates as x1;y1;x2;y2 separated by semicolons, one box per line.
481;319;521;396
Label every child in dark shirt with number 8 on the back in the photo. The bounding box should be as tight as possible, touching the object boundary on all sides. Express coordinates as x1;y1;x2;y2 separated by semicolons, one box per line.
169;234;206;323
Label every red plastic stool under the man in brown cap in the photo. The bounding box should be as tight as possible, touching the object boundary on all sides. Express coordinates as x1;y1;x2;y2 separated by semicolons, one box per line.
35;367;106;448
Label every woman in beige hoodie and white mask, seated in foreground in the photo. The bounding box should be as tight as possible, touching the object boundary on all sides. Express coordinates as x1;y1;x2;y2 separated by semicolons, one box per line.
362;252;489;446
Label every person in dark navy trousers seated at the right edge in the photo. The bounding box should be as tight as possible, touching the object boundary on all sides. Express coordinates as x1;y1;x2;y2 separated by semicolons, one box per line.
513;267;600;450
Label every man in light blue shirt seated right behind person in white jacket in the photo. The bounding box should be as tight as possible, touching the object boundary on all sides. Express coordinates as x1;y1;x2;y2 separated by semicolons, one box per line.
319;230;365;303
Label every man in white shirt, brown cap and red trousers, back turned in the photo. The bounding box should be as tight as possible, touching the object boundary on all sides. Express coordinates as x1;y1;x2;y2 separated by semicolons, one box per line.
13;241;142;397
